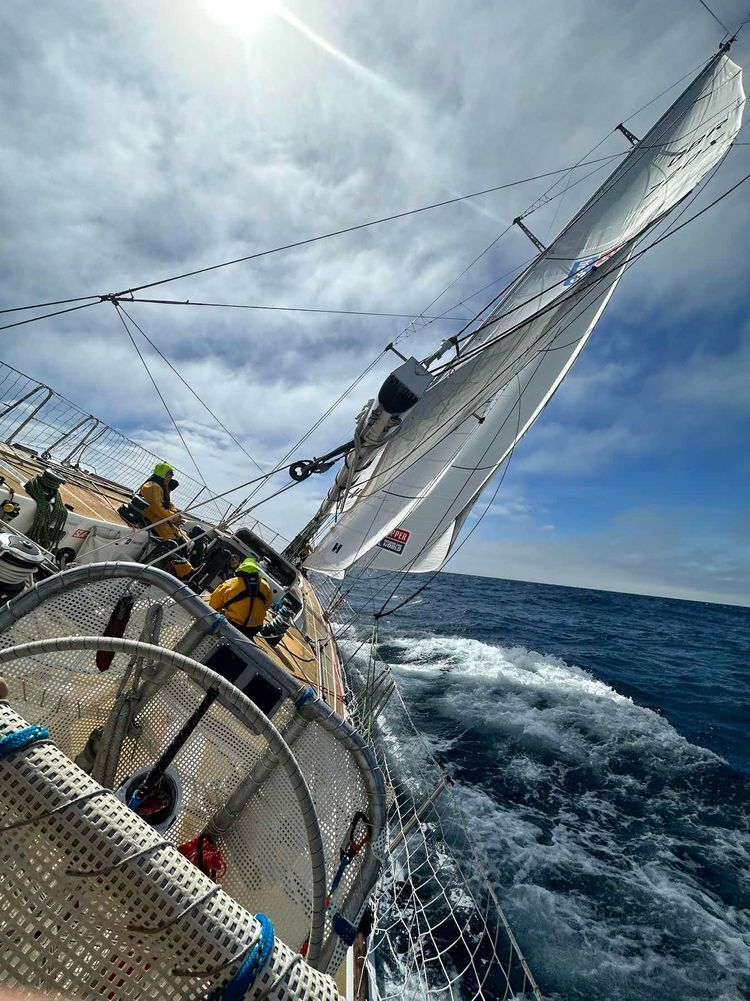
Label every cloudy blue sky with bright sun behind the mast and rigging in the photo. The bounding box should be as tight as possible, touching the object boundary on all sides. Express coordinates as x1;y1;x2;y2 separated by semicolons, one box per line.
0;0;750;604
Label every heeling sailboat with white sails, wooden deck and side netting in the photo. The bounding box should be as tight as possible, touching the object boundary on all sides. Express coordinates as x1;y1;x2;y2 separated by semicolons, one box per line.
0;33;745;1001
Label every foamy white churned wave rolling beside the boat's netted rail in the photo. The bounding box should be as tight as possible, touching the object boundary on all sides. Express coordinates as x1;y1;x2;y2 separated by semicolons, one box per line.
380;634;750;1001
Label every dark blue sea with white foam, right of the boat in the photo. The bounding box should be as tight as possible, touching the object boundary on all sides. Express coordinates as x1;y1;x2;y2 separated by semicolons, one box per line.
340;574;750;1001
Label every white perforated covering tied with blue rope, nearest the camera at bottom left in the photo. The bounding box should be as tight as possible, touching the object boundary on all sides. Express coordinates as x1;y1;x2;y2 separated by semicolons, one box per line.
0;703;338;1001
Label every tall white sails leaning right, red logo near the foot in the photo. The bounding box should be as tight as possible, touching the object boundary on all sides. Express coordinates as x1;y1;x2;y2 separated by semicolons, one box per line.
305;52;745;576
